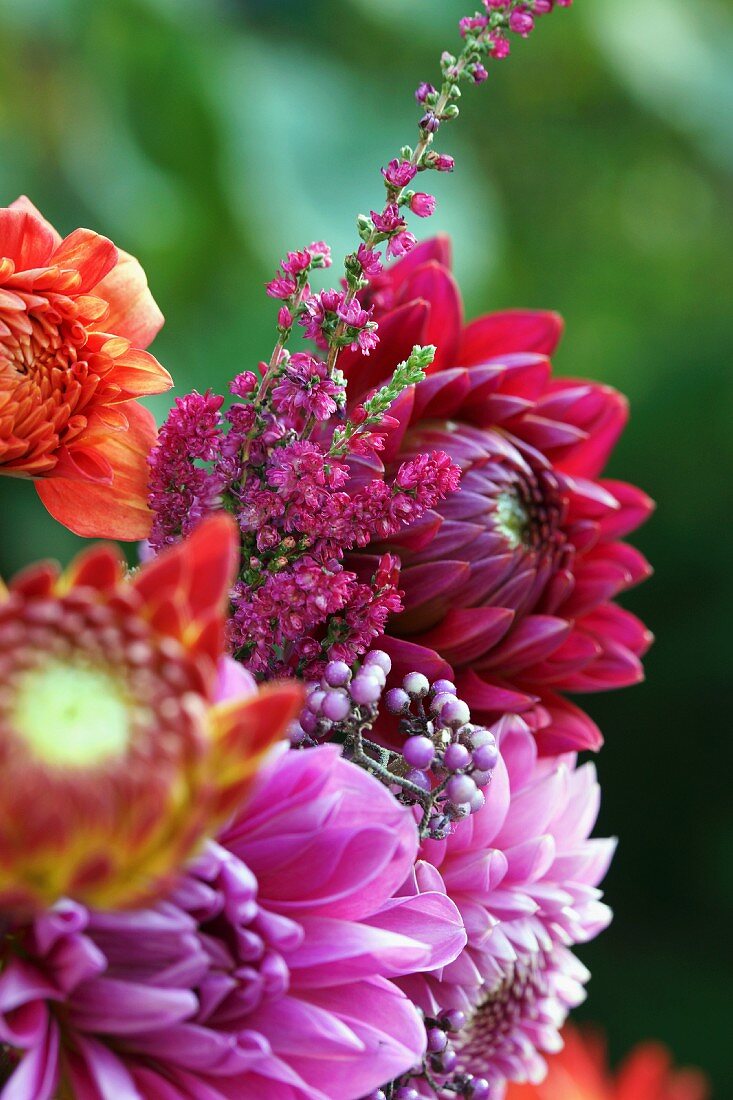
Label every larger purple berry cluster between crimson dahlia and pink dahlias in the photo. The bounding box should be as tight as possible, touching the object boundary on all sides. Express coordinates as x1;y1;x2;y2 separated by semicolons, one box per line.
291;650;499;839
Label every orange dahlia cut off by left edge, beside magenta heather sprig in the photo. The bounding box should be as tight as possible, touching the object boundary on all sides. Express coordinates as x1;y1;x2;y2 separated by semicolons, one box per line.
0;198;171;539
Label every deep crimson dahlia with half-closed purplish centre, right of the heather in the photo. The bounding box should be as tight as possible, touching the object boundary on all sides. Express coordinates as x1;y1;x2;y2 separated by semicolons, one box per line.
339;240;652;754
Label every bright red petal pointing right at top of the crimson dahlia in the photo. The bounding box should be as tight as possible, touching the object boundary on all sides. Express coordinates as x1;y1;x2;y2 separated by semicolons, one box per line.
458;309;564;366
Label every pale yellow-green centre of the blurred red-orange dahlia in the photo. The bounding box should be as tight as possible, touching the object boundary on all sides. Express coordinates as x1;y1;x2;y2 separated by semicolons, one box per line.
11;661;133;768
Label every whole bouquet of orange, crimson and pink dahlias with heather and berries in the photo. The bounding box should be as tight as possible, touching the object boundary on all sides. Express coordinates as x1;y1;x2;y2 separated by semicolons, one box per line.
0;0;702;1100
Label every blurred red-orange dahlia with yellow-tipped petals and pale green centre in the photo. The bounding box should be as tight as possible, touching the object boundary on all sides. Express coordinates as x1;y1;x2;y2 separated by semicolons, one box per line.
0;515;300;915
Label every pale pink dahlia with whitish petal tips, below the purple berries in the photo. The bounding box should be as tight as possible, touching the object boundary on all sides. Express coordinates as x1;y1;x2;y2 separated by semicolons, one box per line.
401;717;615;1100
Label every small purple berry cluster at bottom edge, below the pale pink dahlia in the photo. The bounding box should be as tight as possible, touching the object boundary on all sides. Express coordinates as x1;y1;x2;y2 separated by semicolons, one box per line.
364;1010;491;1100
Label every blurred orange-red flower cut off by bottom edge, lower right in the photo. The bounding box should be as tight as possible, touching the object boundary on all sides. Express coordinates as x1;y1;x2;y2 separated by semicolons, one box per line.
506;1029;710;1100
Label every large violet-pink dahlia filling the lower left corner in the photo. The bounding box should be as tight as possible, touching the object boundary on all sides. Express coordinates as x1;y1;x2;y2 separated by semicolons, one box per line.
0;746;466;1100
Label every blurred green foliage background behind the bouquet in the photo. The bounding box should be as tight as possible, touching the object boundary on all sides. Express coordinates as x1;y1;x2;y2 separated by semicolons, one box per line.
0;0;733;1100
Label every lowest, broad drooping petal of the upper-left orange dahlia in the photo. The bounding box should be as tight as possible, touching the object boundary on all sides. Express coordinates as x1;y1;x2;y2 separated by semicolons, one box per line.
35;402;156;541
